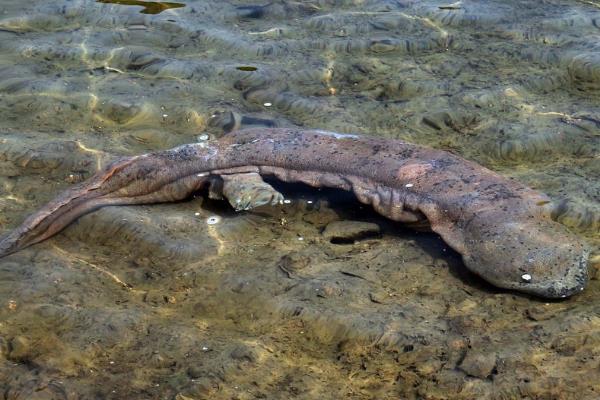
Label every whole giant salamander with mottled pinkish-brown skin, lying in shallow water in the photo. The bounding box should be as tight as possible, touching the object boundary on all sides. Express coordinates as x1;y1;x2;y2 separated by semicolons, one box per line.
0;129;589;298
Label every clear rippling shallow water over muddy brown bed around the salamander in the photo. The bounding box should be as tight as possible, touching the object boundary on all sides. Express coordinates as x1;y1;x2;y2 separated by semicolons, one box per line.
0;0;600;400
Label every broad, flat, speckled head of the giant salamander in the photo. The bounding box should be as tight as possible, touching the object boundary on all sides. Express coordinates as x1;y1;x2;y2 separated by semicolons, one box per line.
463;212;590;298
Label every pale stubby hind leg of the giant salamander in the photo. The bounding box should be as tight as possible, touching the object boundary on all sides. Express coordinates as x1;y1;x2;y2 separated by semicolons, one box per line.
221;172;283;211
